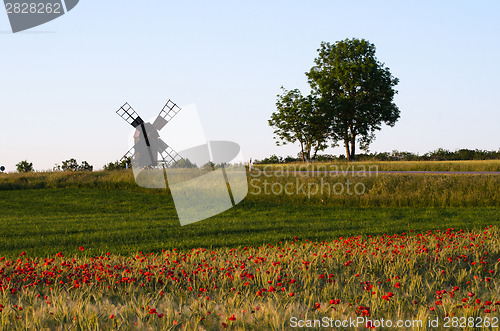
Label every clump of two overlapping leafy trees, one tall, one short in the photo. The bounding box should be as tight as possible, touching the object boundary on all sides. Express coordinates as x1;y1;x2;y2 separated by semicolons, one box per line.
269;38;400;161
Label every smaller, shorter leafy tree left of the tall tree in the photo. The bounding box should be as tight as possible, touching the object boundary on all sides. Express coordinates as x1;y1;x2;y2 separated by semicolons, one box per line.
268;86;328;161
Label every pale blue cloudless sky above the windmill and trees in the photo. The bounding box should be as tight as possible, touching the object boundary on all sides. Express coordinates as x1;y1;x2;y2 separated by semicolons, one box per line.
0;0;500;171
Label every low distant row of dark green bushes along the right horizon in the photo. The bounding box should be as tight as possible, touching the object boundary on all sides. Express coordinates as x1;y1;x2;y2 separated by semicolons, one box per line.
255;148;500;164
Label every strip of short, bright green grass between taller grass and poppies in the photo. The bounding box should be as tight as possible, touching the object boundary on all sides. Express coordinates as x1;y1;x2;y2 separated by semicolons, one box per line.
0;188;500;257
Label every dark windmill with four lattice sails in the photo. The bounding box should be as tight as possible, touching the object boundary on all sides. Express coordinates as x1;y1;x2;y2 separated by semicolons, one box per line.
116;100;181;168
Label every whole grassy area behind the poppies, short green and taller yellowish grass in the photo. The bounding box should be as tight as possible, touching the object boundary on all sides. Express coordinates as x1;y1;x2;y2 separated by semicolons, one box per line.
0;165;500;257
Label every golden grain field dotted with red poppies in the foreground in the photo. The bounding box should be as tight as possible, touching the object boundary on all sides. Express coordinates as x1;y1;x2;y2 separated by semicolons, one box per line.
0;226;500;330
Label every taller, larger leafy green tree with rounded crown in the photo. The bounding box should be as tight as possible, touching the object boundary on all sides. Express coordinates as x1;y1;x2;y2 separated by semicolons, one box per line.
306;39;399;161
